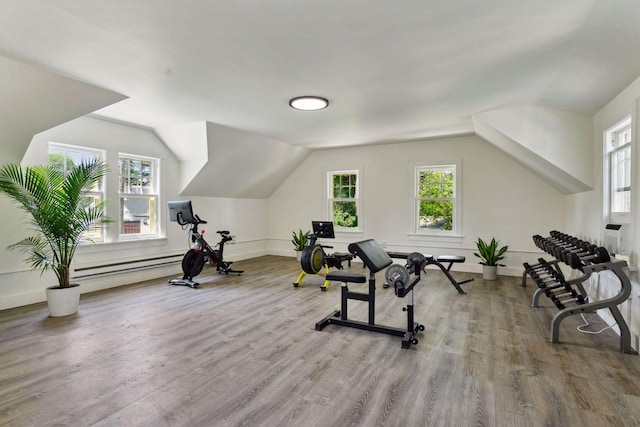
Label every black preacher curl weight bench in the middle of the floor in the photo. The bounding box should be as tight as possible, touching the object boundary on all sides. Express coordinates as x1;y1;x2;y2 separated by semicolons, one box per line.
316;239;424;348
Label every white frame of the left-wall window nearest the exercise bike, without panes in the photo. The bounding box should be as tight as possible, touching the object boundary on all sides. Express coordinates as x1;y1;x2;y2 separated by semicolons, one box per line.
117;153;160;241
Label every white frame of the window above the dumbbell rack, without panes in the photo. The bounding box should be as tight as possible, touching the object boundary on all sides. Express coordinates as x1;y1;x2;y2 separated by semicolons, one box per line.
603;115;635;224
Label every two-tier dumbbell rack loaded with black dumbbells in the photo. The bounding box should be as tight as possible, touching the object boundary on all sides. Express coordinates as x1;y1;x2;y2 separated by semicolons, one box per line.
523;231;637;354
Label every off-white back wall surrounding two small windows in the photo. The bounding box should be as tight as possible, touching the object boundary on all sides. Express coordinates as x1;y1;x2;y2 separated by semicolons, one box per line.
267;136;565;275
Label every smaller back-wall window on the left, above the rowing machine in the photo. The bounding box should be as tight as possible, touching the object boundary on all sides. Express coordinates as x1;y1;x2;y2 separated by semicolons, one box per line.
327;170;360;231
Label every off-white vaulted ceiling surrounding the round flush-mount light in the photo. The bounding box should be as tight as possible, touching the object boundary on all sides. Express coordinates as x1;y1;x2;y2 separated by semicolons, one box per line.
0;0;640;196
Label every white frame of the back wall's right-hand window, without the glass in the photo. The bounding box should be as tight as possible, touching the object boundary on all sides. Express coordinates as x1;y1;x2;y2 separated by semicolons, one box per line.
412;161;462;239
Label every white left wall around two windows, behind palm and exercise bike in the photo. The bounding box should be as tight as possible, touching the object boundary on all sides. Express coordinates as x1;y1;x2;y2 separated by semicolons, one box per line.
0;117;267;310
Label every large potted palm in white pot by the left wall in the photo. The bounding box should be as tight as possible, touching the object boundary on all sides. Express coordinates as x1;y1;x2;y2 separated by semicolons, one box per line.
0;160;112;317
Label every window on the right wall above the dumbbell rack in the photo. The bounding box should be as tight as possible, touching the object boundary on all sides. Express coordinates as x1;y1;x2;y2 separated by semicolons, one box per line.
604;117;632;223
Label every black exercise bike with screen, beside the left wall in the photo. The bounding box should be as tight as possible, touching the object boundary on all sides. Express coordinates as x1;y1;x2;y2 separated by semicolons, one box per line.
169;201;244;288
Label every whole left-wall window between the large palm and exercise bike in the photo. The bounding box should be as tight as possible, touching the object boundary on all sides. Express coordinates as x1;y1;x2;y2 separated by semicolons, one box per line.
118;154;159;236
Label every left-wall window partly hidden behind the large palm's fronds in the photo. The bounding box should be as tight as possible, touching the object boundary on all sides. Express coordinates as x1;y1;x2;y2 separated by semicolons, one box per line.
49;142;106;242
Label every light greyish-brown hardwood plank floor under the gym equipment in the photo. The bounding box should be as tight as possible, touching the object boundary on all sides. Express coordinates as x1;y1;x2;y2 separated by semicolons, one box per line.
0;256;640;427
